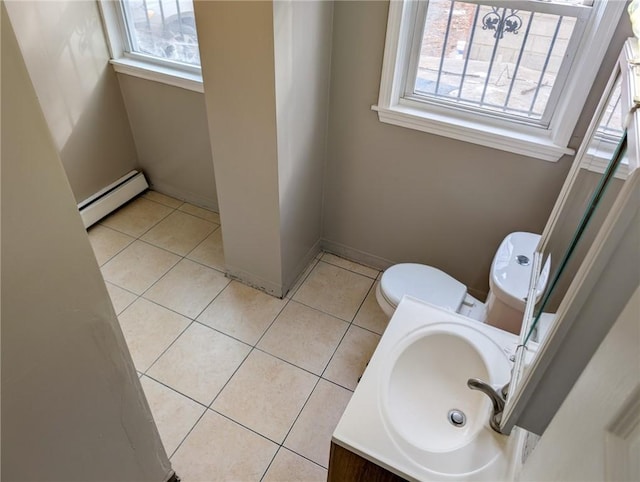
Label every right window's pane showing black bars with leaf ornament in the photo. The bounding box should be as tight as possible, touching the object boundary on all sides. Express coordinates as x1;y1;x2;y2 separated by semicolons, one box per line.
413;0;576;121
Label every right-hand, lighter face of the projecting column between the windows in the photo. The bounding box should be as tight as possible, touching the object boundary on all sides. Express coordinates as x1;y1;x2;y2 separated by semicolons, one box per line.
273;0;333;288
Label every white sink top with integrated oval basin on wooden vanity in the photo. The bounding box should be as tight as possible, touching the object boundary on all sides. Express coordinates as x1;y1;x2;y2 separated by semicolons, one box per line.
333;297;518;480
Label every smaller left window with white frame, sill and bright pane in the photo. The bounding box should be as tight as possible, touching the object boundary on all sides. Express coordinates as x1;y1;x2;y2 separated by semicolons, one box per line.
100;0;202;92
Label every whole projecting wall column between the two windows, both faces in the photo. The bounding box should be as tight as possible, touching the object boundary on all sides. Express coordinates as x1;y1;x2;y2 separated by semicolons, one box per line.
196;0;332;296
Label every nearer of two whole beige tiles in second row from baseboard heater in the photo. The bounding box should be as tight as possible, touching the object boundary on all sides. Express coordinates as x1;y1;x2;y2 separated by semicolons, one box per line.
102;240;180;294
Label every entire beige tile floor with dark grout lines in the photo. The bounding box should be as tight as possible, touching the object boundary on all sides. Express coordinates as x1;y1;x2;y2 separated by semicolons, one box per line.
89;191;387;482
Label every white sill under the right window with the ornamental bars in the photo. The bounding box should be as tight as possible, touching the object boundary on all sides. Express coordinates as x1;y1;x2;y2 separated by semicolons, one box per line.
371;105;575;162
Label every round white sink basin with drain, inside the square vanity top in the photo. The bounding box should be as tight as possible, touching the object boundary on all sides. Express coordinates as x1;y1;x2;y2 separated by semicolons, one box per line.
379;321;510;474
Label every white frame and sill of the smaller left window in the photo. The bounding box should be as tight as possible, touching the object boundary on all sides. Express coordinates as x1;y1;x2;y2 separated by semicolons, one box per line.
98;0;204;93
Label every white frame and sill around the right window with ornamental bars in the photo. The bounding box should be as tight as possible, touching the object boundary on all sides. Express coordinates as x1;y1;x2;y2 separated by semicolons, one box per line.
372;0;626;162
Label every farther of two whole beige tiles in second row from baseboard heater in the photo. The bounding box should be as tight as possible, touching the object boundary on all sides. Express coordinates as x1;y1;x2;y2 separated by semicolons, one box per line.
140;211;217;256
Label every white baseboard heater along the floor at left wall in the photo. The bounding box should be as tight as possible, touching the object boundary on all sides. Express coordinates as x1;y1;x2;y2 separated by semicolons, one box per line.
78;171;149;228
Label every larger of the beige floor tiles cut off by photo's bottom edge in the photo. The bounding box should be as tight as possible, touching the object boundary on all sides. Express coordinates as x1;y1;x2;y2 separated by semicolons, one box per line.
171;410;278;482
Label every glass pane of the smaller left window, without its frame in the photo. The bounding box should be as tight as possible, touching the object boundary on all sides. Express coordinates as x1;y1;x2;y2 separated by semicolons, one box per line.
122;0;200;66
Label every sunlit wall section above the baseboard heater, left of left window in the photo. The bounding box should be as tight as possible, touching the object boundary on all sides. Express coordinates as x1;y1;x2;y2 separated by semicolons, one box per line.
5;0;136;202
